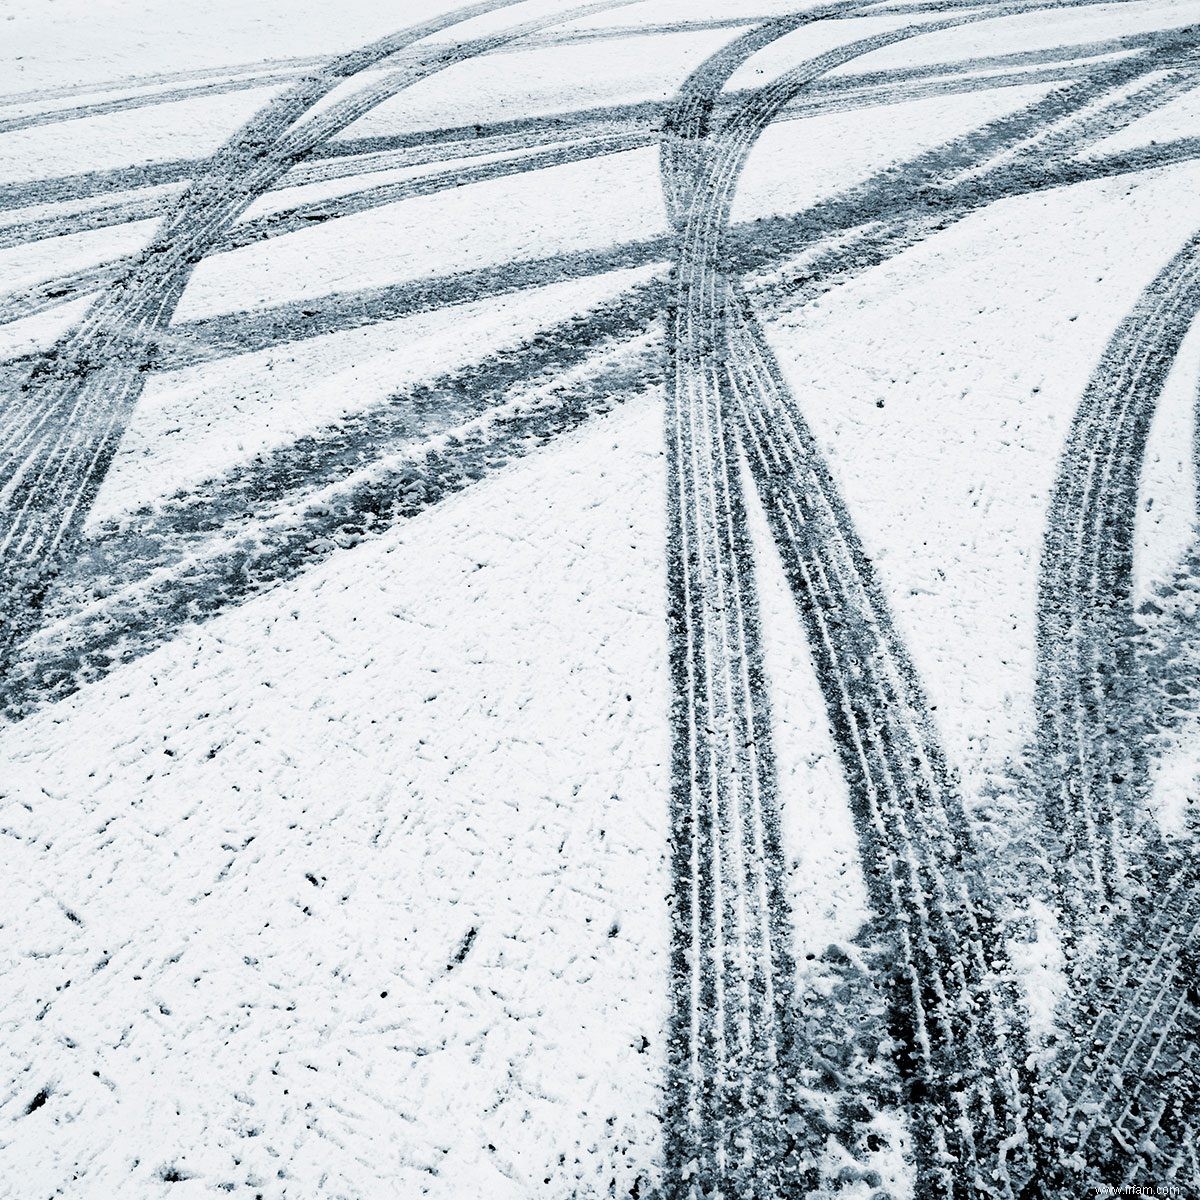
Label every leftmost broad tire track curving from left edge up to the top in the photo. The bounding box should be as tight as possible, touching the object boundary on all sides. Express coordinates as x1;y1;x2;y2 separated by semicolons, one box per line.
0;0;612;659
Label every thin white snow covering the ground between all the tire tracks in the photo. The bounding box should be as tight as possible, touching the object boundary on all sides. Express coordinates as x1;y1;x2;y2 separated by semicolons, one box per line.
0;0;1200;1200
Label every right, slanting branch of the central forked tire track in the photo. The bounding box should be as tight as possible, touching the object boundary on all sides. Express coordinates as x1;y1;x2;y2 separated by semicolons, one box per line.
730;290;1024;1195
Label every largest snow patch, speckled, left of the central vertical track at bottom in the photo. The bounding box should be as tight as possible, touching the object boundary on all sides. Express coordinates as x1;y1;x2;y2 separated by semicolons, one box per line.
0;401;668;1198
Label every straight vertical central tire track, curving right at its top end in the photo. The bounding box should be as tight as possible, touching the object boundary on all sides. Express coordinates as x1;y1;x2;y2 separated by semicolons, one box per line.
660;10;844;1200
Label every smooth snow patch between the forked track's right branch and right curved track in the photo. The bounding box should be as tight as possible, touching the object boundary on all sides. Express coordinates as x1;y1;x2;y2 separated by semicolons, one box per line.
772;154;1200;794
